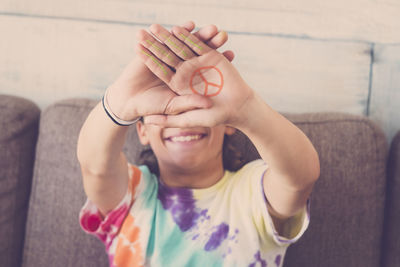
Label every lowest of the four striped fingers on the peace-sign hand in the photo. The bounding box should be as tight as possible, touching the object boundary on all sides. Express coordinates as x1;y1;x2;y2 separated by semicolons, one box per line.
136;44;174;84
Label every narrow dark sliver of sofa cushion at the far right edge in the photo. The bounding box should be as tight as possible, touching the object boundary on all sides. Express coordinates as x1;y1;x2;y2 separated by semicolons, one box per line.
382;131;400;267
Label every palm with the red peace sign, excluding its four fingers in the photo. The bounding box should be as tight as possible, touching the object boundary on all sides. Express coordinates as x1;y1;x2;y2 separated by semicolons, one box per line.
167;50;252;126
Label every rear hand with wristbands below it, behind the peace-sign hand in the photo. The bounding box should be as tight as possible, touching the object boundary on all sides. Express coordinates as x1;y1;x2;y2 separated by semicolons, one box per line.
108;22;234;121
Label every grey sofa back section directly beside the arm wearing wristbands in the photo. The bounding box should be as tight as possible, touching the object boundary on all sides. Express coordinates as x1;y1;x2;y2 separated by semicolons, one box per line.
22;100;108;267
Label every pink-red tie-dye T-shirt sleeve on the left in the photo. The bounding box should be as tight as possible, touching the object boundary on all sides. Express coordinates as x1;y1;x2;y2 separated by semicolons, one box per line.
79;163;142;248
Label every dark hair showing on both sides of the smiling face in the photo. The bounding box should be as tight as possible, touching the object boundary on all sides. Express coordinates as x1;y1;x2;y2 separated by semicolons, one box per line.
138;134;244;176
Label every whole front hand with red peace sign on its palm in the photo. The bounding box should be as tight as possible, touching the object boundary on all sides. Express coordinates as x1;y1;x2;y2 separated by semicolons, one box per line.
137;24;253;127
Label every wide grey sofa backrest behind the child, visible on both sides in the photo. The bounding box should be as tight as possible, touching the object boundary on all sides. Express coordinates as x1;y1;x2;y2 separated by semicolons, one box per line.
23;99;387;267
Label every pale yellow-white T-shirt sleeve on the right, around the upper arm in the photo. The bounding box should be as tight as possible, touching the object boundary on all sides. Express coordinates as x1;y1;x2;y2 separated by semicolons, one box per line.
239;159;310;246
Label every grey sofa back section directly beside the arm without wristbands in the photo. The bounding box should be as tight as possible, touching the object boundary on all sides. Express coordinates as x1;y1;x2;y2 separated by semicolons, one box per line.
285;114;387;267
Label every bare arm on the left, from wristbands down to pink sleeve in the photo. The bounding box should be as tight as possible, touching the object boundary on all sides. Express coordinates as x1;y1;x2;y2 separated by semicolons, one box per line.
77;97;128;215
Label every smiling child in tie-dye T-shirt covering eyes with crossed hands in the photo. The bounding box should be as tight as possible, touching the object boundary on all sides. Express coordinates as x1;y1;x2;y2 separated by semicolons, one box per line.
77;22;319;266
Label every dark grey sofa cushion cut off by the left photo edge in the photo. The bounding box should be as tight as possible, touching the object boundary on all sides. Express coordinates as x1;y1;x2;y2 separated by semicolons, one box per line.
0;95;40;266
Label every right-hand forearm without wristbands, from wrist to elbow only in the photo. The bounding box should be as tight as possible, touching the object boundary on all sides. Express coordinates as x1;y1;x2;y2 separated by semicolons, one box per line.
235;94;319;190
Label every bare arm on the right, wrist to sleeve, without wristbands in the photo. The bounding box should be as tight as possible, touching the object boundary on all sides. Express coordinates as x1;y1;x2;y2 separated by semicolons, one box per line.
234;91;320;232
